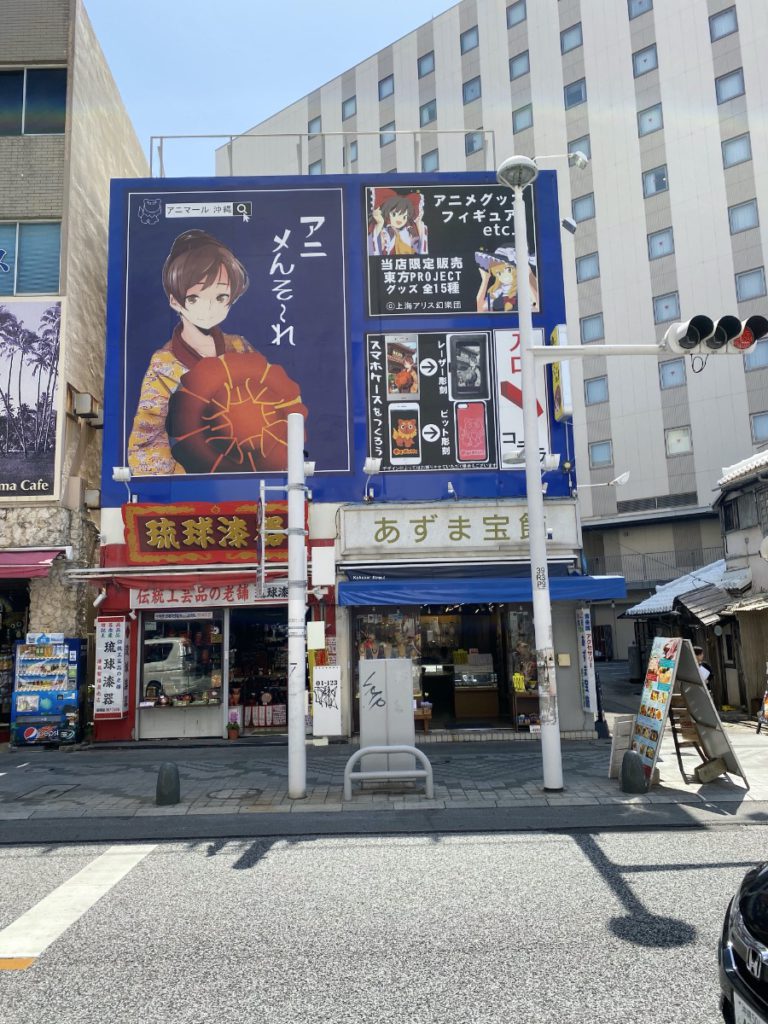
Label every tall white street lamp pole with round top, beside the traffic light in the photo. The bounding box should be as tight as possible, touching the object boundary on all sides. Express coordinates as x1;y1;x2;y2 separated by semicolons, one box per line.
496;153;587;792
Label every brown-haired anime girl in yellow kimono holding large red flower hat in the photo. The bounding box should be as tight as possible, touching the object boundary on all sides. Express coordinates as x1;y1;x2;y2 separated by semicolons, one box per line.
128;229;307;476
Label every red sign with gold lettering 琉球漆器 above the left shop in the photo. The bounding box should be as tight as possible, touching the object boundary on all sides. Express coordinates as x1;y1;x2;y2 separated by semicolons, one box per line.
123;502;288;565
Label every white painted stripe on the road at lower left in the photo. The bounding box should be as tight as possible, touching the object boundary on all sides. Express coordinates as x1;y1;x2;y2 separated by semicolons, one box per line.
0;844;155;959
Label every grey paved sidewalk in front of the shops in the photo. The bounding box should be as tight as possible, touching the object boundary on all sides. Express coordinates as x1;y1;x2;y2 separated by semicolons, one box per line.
0;722;768;843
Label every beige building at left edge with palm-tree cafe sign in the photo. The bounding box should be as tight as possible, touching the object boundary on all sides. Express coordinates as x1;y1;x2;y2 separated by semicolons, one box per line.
0;0;147;730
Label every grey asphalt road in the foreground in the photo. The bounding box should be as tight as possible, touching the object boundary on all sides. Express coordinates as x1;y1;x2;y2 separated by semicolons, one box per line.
0;825;768;1024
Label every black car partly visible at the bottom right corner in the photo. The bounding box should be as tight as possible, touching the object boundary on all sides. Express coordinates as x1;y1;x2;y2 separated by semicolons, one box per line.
718;862;768;1024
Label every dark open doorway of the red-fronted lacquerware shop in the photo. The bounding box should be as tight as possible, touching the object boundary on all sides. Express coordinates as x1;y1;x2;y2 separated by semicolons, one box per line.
228;605;288;735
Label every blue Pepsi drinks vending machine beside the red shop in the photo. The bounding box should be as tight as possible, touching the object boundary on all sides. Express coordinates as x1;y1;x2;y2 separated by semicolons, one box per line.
10;633;85;746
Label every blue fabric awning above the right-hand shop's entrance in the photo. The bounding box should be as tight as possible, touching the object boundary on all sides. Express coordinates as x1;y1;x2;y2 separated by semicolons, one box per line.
338;575;627;605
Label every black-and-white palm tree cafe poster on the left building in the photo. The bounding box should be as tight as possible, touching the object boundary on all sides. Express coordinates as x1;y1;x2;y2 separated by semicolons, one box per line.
0;298;61;502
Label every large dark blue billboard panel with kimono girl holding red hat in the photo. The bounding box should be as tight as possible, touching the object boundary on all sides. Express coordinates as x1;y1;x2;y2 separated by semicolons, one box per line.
124;187;349;477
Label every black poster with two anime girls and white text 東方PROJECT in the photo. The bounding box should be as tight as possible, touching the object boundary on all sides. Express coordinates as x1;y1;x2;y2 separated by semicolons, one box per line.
365;184;540;316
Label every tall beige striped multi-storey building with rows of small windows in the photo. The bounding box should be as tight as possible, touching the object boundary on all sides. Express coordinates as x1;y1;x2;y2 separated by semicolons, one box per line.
217;0;768;656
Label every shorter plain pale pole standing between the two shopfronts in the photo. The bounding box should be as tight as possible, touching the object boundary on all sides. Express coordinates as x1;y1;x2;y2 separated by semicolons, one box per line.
288;413;306;800
